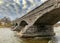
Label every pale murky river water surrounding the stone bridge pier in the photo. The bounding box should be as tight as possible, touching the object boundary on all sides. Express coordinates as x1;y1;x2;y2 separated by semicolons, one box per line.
0;27;60;43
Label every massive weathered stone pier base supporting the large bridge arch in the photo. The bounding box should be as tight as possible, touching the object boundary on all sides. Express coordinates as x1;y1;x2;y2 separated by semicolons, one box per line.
18;25;55;38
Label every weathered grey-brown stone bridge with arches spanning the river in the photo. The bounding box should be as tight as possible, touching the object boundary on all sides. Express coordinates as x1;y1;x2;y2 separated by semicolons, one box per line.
14;0;60;38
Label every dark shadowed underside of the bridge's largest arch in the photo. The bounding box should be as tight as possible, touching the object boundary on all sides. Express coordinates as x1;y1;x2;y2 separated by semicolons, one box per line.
34;8;60;25
